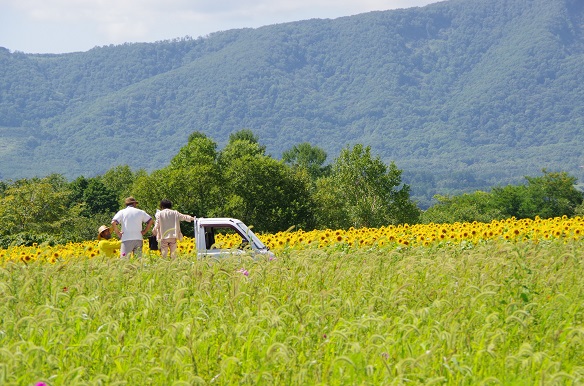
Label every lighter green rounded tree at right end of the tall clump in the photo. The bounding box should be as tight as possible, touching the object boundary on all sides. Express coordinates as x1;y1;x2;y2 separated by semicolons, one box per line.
317;144;419;228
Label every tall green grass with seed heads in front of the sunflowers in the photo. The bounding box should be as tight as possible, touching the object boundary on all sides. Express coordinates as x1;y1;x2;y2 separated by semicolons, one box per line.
0;239;584;385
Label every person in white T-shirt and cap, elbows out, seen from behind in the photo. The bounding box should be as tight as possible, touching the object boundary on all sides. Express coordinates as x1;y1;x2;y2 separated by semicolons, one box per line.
112;197;153;258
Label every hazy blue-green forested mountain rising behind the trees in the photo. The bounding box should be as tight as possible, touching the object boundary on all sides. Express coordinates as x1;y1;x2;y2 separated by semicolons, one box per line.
0;0;584;205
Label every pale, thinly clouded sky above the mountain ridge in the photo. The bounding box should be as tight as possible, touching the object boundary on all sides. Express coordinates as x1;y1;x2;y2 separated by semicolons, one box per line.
0;0;438;54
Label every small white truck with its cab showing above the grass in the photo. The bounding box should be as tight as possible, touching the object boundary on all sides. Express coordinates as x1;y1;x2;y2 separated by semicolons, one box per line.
194;217;275;258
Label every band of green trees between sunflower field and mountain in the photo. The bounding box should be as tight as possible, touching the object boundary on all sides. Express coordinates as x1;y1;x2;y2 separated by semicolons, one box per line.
0;129;583;248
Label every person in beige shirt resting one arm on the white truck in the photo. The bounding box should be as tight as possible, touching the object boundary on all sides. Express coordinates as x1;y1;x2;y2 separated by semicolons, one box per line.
152;199;195;259
